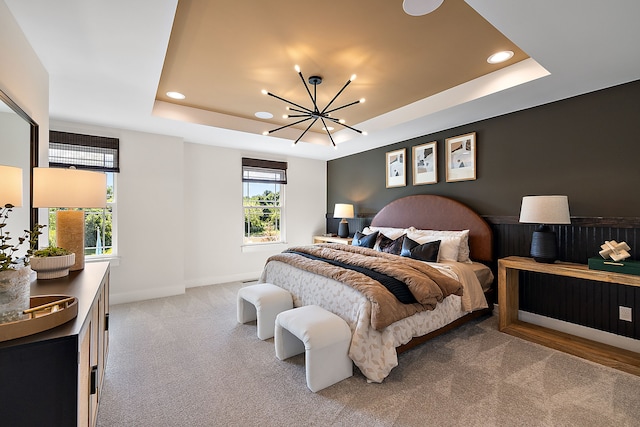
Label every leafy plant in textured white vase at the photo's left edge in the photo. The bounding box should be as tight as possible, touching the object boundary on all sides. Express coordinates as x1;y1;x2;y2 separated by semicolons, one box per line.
0;204;44;323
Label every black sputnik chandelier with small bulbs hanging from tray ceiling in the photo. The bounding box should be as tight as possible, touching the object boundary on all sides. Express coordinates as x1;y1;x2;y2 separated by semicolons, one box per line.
262;65;366;147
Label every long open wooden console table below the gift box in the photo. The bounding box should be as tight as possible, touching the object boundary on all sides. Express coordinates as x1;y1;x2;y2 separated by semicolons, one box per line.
498;256;640;376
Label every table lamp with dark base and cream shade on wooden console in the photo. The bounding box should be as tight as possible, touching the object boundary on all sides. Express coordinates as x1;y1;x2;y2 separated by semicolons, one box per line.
520;196;571;263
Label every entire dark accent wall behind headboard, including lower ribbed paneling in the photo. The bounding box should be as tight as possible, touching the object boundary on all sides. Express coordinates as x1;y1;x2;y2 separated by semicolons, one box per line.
327;80;640;339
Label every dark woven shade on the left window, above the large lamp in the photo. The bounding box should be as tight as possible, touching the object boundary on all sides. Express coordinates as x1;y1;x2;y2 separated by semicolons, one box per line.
49;130;120;172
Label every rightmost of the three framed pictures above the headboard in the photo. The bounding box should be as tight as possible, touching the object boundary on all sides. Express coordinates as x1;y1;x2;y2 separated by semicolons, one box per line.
445;132;477;182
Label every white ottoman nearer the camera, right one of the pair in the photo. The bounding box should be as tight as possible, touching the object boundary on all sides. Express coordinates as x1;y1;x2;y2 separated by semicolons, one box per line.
274;305;353;392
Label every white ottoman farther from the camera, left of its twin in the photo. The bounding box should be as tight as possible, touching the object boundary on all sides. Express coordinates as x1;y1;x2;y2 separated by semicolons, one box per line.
237;283;293;340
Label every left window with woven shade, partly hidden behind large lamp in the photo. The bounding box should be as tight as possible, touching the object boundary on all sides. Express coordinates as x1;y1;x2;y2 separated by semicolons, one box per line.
49;131;120;257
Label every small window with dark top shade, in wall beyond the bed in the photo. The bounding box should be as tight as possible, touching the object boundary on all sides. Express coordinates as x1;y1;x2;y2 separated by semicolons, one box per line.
242;158;287;245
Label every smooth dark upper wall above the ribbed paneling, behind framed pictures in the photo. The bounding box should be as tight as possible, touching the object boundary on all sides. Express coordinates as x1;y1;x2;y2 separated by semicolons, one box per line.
327;81;640;217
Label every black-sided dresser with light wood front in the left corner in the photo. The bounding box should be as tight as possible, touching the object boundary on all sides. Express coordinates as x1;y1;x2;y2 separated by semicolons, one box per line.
0;262;109;427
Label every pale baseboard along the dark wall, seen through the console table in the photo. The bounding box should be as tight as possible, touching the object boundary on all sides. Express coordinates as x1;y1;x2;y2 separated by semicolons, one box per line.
493;304;640;353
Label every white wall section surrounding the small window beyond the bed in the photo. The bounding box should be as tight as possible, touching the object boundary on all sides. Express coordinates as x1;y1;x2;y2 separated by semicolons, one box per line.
184;143;327;287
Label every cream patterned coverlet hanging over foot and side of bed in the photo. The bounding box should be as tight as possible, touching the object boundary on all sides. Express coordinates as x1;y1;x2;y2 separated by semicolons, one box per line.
260;261;487;382
